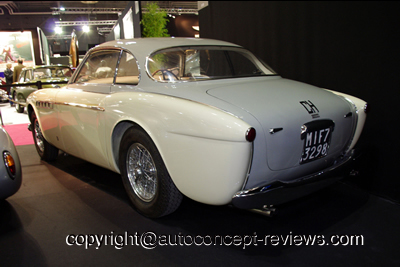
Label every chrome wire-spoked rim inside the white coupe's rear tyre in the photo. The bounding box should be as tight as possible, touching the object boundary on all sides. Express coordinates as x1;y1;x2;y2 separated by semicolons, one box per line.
126;143;157;202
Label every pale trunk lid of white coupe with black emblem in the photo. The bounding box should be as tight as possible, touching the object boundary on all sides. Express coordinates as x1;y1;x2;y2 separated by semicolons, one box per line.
207;78;355;170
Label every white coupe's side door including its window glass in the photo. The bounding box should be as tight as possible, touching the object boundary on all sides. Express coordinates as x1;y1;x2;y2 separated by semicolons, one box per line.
56;49;120;168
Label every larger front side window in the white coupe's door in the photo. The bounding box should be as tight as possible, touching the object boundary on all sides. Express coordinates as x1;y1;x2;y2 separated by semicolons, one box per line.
76;50;120;84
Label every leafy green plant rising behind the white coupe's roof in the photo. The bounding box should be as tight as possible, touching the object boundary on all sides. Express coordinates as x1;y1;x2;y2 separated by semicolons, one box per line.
140;2;170;37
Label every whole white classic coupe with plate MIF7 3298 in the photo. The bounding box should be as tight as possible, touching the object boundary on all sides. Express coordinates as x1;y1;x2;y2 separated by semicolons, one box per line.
28;38;367;218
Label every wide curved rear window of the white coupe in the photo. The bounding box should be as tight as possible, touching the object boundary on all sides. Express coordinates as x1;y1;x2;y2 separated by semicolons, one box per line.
147;46;276;82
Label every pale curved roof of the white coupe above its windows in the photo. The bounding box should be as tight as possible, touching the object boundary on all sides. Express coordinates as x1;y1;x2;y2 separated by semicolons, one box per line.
95;37;241;55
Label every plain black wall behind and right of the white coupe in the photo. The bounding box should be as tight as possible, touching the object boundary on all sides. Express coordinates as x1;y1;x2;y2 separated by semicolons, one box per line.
199;1;400;202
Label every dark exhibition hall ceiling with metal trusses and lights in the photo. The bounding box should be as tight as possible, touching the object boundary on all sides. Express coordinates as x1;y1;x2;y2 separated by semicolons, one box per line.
0;1;198;38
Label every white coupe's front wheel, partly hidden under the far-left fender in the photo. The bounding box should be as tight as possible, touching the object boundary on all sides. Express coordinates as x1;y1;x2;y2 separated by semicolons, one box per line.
31;113;58;161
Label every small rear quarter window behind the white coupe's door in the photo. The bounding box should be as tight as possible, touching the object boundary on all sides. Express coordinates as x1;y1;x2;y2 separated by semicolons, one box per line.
115;51;140;85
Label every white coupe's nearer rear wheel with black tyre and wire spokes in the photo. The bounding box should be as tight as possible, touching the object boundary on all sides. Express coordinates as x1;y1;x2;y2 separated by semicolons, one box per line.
119;127;183;218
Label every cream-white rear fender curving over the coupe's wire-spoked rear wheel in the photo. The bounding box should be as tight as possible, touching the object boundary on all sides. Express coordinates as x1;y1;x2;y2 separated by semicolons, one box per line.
106;93;252;205
